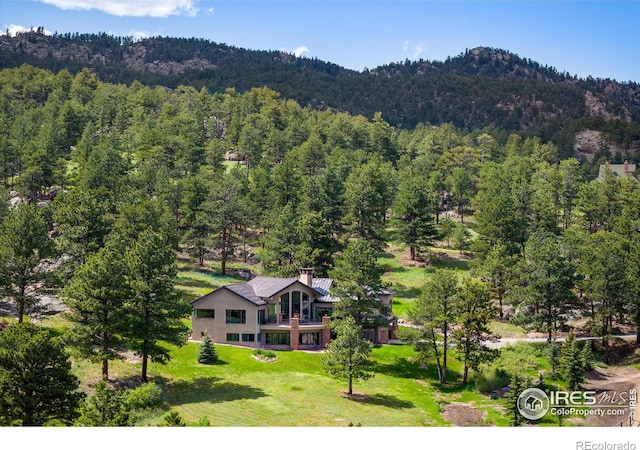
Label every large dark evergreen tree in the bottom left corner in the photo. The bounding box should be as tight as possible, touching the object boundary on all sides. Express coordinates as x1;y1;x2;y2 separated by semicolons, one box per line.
0;322;84;426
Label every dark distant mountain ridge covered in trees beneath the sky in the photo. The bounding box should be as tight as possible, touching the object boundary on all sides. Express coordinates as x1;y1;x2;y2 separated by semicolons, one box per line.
0;33;640;157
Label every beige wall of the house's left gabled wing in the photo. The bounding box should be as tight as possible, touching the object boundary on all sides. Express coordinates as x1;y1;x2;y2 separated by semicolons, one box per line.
191;289;266;347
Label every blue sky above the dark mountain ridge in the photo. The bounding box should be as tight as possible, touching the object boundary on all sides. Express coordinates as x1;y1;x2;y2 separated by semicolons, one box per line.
0;0;640;82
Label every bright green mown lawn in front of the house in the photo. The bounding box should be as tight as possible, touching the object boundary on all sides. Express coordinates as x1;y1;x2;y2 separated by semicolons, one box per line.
58;343;507;427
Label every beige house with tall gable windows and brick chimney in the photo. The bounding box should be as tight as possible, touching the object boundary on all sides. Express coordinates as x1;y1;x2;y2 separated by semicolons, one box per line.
191;268;397;350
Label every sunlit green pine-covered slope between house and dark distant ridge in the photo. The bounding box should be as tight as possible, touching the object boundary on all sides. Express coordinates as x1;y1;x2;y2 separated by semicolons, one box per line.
0;62;640;356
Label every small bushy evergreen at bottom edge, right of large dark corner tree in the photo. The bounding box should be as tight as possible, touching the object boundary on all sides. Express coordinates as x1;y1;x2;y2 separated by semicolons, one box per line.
77;379;133;427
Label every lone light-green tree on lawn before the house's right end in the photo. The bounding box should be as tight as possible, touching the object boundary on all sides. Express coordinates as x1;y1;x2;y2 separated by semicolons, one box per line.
322;317;373;395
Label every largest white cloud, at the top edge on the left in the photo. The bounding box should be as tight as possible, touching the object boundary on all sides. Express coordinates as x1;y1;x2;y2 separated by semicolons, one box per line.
33;0;198;17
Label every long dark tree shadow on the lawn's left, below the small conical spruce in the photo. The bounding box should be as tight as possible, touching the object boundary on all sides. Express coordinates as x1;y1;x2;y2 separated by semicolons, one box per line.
166;377;266;405
